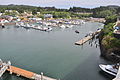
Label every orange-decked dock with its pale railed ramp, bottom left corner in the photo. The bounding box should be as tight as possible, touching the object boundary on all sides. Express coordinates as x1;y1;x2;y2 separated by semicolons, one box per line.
0;59;57;80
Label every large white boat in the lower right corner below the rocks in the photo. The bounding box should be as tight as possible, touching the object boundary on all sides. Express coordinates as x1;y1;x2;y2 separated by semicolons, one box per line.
99;64;119;76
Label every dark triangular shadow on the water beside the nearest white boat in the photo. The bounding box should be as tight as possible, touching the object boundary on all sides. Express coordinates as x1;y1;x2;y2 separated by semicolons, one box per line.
61;46;114;80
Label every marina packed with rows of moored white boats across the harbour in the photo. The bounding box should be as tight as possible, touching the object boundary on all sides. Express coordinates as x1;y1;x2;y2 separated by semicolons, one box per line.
12;19;85;32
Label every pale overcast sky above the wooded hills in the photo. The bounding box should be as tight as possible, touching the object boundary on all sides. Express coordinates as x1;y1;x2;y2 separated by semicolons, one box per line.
0;0;120;8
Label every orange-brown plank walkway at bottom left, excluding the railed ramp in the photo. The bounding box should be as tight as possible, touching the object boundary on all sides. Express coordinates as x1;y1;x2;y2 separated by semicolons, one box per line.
7;66;57;80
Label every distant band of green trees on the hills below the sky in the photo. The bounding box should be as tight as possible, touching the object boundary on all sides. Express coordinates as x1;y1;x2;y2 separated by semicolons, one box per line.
0;4;120;18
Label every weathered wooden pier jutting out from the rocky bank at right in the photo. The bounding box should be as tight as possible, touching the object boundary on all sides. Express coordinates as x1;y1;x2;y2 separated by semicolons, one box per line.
75;29;101;45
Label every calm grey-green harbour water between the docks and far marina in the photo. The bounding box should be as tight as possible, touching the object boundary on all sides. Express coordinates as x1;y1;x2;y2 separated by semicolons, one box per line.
0;22;114;80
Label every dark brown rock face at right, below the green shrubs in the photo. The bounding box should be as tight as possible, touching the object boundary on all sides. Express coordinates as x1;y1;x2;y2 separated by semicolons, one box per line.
99;31;120;63
